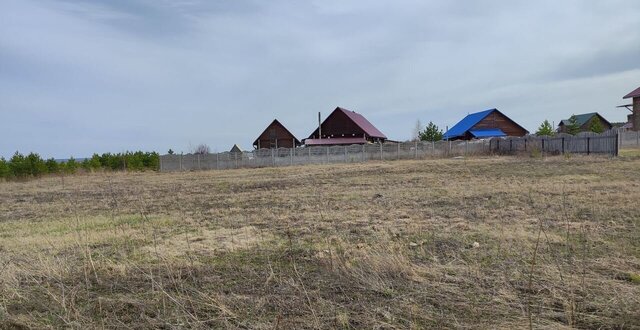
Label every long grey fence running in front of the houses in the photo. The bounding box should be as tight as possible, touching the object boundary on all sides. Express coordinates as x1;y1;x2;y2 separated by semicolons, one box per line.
160;131;638;172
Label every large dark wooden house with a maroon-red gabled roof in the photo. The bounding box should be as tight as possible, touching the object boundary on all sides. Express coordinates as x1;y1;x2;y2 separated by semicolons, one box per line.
304;107;387;146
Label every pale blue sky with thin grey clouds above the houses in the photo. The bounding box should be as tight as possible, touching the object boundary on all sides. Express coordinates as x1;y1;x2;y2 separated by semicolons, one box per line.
0;0;640;158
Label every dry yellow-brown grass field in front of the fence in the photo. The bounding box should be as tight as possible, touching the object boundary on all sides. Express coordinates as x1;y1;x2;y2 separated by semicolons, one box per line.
0;157;640;329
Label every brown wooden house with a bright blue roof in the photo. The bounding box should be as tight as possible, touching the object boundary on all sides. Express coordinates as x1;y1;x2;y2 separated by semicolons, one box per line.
443;109;529;140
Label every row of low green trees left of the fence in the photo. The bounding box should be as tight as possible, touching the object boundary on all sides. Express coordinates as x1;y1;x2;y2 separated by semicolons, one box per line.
0;151;160;180
